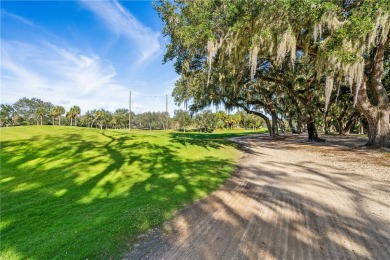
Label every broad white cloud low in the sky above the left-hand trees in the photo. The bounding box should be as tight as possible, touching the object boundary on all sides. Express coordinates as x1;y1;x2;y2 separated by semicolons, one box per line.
1;41;128;110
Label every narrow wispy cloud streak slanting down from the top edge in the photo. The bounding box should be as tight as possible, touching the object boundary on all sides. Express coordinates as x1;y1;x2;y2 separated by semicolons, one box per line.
81;0;161;62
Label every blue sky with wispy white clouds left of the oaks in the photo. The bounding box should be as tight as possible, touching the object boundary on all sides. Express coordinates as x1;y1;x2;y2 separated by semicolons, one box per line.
1;0;179;113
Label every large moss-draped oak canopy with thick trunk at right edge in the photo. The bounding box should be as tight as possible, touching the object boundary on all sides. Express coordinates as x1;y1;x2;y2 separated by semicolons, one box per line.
156;0;390;146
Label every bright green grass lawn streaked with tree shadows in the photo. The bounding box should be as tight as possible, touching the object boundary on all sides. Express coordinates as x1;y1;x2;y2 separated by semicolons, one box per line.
0;126;266;259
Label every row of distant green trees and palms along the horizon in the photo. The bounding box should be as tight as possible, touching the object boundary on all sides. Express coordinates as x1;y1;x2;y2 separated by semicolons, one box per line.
0;98;264;131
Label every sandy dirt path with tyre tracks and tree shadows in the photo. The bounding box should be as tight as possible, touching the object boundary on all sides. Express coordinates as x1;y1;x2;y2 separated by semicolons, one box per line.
126;136;390;259
